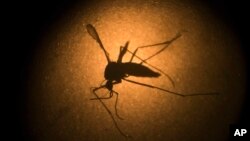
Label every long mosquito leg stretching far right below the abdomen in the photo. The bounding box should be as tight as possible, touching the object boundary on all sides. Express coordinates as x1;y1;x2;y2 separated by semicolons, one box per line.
123;78;219;97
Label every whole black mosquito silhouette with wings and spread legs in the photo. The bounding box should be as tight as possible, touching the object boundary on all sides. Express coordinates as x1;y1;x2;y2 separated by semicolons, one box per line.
86;24;218;138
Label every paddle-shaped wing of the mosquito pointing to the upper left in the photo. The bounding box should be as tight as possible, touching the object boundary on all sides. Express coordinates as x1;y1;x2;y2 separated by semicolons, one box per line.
86;24;111;63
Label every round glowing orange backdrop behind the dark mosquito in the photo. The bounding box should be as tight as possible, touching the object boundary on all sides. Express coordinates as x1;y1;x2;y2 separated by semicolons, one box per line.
27;0;245;141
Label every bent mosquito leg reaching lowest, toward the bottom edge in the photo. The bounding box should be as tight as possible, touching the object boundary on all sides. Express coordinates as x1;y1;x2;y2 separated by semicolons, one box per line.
92;86;130;138
